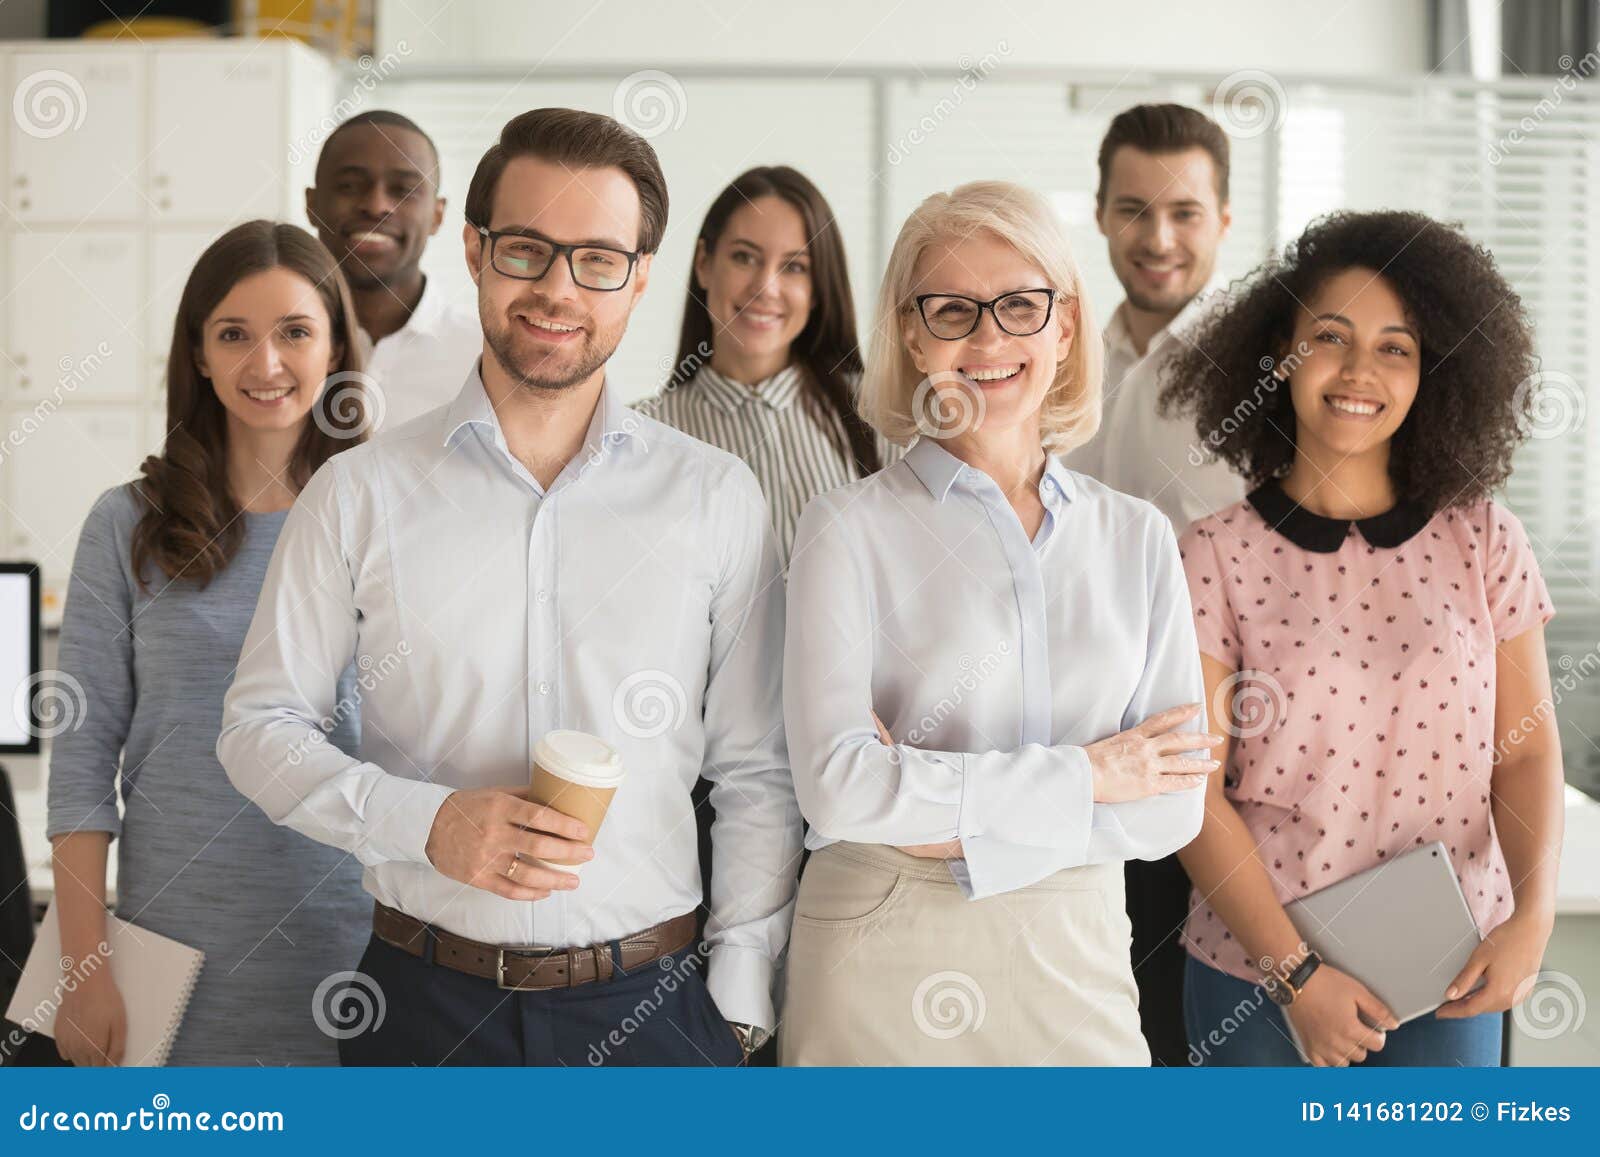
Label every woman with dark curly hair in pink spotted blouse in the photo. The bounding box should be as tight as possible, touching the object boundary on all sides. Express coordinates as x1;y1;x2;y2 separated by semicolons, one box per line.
1162;213;1562;1066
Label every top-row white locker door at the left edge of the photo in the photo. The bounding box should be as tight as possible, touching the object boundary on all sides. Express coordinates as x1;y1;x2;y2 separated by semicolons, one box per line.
6;51;144;222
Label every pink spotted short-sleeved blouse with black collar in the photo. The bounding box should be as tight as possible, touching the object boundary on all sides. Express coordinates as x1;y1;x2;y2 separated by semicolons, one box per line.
1179;483;1554;981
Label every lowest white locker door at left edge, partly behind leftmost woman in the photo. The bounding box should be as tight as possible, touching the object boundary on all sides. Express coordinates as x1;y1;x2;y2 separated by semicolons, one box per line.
0;403;149;591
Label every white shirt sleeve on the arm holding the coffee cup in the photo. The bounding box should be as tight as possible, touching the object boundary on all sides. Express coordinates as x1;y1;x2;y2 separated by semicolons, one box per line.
216;459;453;866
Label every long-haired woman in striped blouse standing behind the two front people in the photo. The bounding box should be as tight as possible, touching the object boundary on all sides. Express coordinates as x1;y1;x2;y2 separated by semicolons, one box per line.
637;165;891;568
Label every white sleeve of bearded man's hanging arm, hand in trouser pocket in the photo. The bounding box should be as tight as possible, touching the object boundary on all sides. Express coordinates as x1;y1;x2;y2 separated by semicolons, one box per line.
702;466;802;1029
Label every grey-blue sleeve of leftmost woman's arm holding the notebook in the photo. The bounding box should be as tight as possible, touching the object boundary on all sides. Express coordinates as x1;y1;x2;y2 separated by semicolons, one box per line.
38;486;138;839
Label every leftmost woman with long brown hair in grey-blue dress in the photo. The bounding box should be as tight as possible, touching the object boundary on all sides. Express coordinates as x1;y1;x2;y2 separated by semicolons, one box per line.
48;221;370;1066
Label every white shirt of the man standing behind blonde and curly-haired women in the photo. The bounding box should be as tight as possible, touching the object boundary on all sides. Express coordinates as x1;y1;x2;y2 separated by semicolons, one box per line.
1066;282;1245;534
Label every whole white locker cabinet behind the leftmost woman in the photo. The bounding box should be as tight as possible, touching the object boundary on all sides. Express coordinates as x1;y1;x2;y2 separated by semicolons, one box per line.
0;38;334;597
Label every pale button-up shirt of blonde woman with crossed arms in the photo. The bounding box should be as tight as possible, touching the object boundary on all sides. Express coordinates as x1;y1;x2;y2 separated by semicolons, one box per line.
784;438;1205;899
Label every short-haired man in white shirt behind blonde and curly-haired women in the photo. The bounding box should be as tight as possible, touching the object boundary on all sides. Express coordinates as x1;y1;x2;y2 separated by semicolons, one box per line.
1067;104;1245;1064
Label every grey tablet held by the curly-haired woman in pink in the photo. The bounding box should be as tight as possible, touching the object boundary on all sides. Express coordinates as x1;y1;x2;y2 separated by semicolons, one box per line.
1283;840;1483;1058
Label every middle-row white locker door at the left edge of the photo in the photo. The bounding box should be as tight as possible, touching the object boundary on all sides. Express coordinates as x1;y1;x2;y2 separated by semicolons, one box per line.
6;229;144;402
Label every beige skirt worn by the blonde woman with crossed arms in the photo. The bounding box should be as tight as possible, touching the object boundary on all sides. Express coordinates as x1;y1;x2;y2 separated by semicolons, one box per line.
778;843;1150;1066
